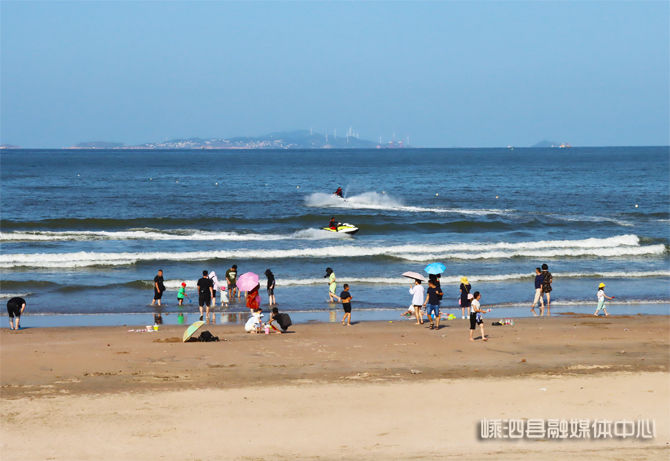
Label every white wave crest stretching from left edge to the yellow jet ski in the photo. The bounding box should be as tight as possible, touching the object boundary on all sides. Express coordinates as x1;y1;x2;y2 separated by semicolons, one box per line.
0;228;350;242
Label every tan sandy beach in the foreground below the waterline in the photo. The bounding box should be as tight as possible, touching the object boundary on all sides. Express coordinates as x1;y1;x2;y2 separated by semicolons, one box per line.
0;313;670;460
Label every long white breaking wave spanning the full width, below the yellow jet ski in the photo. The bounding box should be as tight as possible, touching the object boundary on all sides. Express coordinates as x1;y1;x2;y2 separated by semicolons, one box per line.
2;235;666;268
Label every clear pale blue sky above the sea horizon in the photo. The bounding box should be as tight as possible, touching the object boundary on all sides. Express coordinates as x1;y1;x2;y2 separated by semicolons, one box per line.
0;0;670;147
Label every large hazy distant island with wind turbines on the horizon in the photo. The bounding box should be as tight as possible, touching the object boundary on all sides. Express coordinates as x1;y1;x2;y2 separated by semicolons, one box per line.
69;130;408;149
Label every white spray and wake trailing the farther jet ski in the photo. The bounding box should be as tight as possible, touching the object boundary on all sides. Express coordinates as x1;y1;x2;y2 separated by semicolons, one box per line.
305;192;511;215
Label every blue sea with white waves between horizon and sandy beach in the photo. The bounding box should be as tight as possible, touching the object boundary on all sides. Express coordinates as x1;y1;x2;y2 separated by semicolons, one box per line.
0;147;670;327
